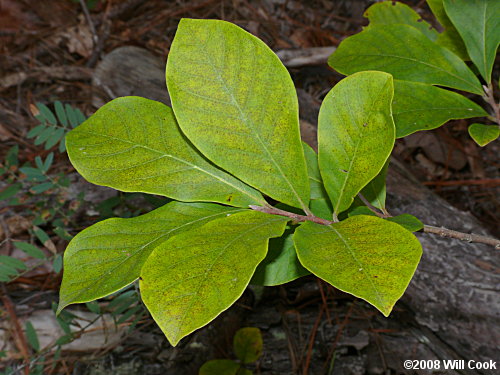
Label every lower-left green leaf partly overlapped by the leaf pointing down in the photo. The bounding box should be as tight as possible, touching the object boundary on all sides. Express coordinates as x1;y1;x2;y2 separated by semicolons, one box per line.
58;202;242;312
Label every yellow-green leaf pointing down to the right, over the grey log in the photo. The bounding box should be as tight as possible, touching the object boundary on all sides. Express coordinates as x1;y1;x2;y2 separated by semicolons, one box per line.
294;215;422;316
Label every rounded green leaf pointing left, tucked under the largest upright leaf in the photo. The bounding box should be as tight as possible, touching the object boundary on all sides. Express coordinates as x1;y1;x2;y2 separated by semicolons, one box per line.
66;96;263;207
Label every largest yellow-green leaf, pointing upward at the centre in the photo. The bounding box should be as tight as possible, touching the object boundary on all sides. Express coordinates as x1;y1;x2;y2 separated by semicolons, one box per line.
166;19;309;208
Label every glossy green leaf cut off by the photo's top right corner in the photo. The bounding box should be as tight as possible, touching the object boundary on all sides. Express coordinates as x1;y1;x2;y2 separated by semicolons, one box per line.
443;0;500;83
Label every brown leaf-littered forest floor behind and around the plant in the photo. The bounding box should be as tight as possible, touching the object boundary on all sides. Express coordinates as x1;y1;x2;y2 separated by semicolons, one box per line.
0;0;500;375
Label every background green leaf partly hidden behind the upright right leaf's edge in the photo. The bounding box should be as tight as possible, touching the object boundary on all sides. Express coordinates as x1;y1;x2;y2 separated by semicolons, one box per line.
392;80;488;138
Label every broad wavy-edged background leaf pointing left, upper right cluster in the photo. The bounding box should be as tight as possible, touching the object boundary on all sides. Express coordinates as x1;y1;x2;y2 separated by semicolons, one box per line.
328;25;483;95
